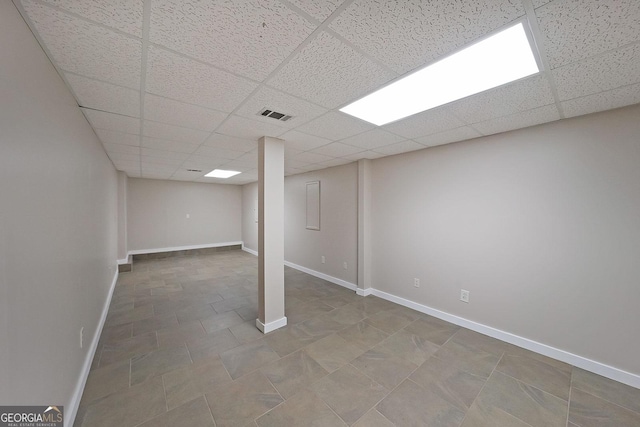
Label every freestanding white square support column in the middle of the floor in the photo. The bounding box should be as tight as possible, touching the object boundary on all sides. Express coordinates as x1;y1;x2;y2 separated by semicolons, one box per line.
256;136;287;334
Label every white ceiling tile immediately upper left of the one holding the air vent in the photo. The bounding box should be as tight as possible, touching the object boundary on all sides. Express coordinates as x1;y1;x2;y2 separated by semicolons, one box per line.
146;46;258;112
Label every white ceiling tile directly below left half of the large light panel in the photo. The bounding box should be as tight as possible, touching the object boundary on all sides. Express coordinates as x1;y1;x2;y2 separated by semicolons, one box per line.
382;105;465;139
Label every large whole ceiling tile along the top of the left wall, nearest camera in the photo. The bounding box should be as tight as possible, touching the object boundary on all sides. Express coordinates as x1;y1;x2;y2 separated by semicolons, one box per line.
22;0;142;89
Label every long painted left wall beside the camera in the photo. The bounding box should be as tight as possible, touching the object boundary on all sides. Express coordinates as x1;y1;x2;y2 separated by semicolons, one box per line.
0;1;117;416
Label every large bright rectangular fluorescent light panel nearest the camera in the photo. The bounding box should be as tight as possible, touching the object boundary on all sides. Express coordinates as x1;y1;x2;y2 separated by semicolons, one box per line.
340;22;540;126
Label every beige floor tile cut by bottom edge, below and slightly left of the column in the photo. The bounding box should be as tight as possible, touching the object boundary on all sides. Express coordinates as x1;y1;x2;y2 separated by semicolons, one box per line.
206;372;283;427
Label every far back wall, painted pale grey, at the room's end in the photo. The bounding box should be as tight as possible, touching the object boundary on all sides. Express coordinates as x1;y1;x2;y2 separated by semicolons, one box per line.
127;178;242;251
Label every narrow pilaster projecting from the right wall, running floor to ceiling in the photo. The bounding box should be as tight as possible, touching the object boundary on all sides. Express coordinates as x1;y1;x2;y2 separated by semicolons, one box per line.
356;159;371;296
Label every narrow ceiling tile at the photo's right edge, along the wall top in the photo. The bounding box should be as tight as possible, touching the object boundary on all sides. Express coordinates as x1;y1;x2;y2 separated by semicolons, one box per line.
562;83;640;117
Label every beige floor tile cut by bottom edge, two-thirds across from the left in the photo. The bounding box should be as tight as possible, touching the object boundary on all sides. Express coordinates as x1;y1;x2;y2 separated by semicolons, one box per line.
376;380;464;427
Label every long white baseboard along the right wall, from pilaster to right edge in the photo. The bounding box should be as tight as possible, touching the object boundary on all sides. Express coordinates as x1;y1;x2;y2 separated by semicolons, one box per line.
372;289;640;388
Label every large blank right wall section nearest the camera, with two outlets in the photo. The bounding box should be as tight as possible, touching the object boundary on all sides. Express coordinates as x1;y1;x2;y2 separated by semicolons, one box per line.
372;106;640;374
